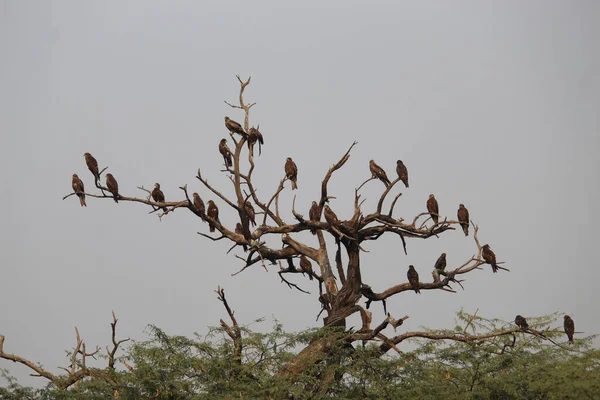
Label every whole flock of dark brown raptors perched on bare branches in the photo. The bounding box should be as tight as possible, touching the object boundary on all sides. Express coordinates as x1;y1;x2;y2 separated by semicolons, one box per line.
72;117;575;344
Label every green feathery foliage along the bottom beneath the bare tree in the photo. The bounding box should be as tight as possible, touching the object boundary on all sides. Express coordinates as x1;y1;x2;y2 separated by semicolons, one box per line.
0;312;600;400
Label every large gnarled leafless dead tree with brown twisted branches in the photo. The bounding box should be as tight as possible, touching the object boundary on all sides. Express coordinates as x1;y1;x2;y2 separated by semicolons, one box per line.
63;76;514;382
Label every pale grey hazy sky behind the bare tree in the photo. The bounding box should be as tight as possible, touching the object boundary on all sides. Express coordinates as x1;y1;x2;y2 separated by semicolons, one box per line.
0;0;600;383
